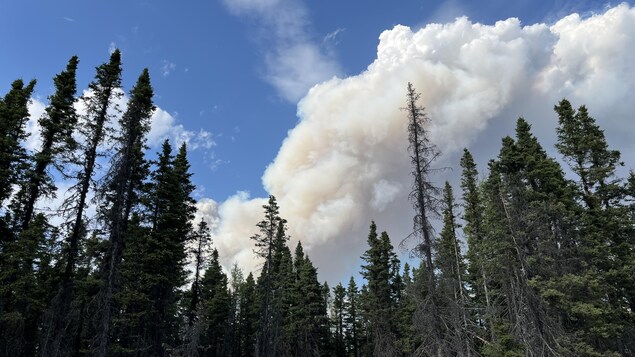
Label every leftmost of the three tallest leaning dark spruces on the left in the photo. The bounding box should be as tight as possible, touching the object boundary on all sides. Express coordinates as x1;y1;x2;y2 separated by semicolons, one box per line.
0;56;78;356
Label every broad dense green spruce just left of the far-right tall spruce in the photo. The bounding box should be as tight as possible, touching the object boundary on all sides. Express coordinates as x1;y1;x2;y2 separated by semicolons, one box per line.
480;118;570;354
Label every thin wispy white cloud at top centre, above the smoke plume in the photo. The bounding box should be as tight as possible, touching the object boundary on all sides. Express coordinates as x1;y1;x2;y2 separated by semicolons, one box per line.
224;0;341;102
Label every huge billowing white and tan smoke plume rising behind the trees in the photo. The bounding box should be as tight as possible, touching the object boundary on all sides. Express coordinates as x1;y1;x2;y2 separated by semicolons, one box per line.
204;4;635;280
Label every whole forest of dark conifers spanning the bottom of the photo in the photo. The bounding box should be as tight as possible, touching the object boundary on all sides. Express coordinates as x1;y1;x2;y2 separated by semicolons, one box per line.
0;50;635;357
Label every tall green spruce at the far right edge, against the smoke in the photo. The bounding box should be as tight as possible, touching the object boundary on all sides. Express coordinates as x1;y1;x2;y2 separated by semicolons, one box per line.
554;99;635;355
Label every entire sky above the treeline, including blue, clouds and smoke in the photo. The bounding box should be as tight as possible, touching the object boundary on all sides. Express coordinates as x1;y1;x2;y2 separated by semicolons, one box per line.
0;0;635;281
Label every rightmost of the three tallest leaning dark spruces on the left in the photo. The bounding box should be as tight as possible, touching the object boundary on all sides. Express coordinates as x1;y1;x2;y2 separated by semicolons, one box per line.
94;69;154;357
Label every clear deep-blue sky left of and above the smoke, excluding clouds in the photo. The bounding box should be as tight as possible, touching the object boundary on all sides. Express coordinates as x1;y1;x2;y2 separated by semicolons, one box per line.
0;0;606;200
